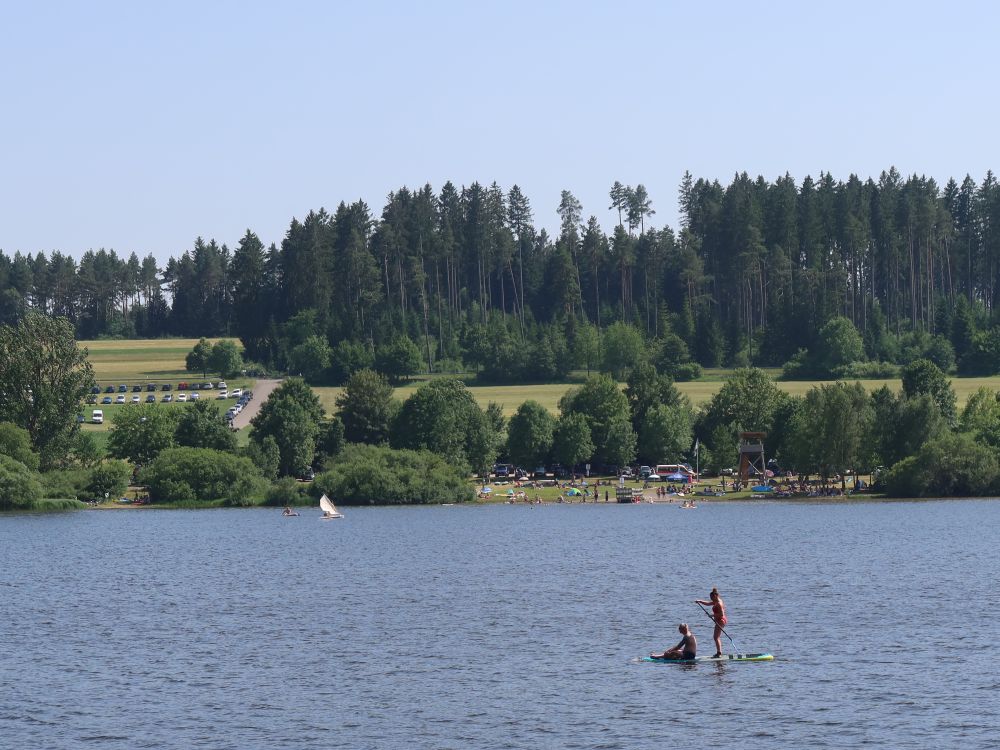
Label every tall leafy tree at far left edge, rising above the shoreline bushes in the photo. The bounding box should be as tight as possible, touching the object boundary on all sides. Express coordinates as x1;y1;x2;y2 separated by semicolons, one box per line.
0;311;94;468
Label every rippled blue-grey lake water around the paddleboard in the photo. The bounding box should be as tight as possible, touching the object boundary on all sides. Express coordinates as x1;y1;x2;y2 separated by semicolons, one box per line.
0;501;1000;750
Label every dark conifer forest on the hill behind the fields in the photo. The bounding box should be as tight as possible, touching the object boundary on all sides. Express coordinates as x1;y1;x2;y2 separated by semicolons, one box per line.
0;169;1000;381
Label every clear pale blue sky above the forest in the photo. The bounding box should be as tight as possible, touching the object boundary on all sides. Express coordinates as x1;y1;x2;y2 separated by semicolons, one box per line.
0;0;1000;260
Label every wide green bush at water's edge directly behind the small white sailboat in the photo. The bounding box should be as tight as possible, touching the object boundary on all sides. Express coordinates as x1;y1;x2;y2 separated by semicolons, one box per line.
312;445;473;505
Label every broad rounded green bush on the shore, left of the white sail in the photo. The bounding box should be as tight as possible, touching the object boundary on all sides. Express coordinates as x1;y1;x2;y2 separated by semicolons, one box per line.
139;448;264;505
